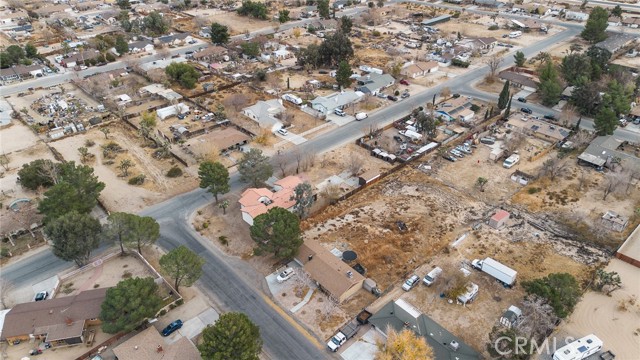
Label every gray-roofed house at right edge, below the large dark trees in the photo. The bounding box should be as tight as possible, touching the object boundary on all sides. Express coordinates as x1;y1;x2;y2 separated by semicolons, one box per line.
578;135;640;172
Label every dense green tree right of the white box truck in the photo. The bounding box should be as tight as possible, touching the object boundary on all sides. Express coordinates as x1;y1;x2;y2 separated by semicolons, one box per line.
522;273;580;319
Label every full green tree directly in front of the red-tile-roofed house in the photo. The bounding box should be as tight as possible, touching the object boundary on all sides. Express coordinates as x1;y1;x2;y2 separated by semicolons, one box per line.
250;207;302;259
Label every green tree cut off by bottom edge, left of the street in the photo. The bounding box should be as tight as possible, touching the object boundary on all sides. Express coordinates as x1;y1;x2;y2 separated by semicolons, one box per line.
198;312;262;360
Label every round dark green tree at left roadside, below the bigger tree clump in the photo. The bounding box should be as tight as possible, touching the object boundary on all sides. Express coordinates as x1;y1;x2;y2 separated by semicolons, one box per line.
44;211;102;267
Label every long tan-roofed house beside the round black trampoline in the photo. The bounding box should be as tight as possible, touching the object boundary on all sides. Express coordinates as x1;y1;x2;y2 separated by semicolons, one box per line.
295;240;364;303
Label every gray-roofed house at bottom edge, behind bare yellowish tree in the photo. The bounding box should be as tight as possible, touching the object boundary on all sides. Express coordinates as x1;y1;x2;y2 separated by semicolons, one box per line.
369;299;480;360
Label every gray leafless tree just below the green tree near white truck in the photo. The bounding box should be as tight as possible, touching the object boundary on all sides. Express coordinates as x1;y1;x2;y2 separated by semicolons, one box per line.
516;295;558;340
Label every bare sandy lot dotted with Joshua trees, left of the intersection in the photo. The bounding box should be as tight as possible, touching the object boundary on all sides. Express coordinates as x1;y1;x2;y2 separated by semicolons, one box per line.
51;124;197;212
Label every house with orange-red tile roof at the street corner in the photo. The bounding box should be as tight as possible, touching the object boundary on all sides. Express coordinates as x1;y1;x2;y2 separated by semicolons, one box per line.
238;175;302;225
